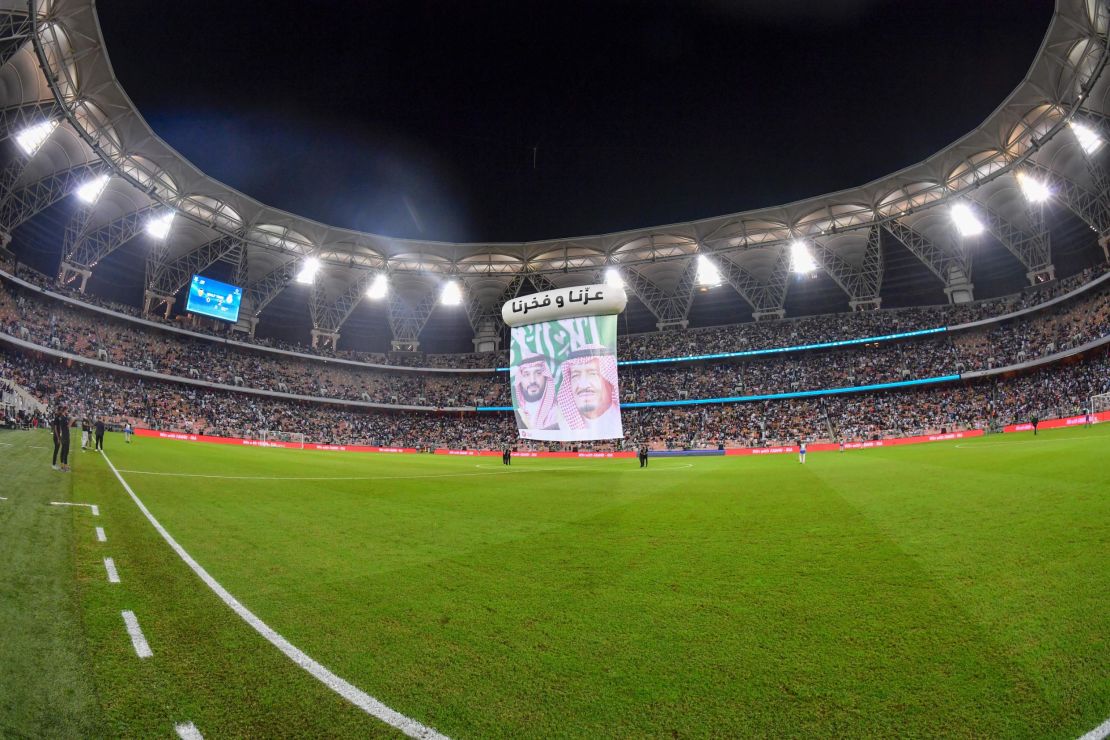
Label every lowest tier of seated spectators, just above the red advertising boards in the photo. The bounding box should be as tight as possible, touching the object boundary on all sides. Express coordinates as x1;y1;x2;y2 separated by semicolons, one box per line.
0;348;1110;449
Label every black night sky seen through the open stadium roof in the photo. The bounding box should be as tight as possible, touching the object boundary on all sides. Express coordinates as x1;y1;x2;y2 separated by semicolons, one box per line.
98;0;1053;241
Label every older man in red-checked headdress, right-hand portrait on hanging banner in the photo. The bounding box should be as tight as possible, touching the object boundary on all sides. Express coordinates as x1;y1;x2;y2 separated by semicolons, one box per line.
557;344;624;439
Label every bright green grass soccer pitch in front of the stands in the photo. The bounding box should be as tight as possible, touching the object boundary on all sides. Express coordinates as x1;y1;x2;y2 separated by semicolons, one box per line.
0;425;1110;738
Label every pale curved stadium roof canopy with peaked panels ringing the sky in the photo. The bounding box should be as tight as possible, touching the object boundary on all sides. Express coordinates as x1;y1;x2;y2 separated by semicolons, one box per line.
0;0;1110;341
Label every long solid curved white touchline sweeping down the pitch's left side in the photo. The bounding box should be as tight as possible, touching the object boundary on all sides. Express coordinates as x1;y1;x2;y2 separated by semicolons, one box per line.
104;455;446;740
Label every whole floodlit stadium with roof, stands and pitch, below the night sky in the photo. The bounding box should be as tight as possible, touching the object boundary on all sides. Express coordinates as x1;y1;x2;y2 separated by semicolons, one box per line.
0;0;1110;740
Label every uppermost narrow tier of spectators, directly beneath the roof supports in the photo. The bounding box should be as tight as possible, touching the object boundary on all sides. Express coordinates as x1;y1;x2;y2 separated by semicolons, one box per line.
0;255;1110;369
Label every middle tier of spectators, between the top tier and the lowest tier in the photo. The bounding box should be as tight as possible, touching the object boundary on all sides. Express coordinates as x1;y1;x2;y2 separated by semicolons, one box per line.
0;274;1110;408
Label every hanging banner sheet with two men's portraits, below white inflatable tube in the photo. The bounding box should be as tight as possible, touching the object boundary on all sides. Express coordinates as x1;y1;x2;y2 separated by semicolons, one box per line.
508;306;624;442
